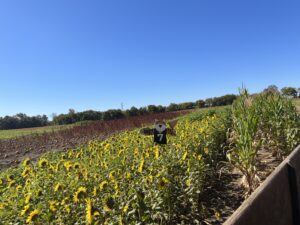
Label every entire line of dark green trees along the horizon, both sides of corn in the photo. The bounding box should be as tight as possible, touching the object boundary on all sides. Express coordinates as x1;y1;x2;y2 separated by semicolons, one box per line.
0;85;300;130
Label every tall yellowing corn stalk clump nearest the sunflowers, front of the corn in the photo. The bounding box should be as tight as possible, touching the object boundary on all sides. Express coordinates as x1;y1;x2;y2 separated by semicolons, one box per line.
227;89;262;194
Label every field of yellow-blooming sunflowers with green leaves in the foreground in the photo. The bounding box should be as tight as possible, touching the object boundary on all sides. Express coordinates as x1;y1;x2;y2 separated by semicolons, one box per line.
0;110;231;225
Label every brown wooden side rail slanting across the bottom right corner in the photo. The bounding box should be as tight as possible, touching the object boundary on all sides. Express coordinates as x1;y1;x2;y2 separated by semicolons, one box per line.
224;145;300;225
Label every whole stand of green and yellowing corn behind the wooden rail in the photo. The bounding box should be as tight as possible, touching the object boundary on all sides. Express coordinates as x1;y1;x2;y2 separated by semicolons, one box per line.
227;89;300;194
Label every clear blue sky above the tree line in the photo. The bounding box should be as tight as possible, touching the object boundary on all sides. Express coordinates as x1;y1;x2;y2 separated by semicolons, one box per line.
0;0;300;116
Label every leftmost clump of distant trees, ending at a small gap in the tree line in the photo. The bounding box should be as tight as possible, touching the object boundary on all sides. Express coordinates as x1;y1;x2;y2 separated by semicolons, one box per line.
0;113;49;130
